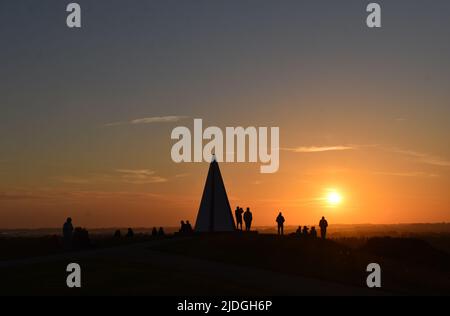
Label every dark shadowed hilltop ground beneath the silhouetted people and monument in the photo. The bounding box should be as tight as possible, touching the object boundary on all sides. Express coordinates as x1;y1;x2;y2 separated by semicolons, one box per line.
0;234;450;296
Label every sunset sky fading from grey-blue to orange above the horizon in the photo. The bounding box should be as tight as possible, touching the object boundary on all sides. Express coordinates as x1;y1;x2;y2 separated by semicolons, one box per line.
0;0;450;228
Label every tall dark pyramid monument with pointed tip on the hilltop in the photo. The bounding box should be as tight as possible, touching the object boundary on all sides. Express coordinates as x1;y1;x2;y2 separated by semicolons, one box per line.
195;157;236;232
